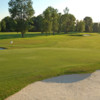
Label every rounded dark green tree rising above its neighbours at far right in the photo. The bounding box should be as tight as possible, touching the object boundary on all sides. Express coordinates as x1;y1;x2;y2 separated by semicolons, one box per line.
84;17;93;32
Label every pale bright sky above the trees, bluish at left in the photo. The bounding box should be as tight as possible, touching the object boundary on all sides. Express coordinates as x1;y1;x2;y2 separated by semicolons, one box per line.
0;0;100;22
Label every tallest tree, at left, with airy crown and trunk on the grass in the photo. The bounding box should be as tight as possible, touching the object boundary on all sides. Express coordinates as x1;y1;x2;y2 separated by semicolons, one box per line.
8;0;34;37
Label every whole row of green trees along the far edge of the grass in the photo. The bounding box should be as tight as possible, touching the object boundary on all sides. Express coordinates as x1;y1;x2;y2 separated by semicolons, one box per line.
0;0;100;37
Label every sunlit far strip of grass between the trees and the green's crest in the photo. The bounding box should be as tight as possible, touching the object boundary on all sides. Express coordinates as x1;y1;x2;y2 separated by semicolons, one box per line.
0;33;100;49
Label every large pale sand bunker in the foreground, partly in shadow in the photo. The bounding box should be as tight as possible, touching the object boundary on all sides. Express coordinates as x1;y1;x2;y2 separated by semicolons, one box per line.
6;71;100;100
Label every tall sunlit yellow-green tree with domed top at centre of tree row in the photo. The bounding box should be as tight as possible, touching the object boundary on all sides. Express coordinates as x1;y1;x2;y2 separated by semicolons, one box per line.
43;7;58;34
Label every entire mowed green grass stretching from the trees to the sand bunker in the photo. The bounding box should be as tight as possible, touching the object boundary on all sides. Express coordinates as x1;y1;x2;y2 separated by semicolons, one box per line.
0;33;100;100
